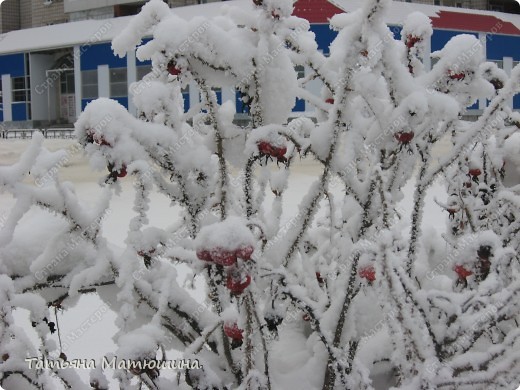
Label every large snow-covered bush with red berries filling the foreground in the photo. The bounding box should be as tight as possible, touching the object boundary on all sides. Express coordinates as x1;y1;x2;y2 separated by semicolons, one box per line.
0;0;520;390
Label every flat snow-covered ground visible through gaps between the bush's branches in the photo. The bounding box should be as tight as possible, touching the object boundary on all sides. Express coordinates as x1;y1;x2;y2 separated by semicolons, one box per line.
0;136;447;386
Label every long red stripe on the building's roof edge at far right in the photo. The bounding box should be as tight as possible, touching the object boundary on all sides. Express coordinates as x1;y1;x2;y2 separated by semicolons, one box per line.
430;11;520;35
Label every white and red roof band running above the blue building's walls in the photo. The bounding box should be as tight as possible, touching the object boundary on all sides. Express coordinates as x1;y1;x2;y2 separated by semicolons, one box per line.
0;0;520;54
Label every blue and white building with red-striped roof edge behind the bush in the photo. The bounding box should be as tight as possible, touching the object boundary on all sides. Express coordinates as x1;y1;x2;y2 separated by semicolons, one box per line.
0;0;520;129
